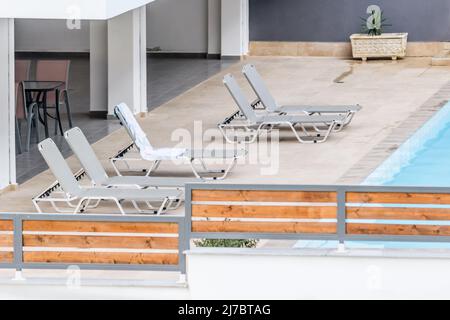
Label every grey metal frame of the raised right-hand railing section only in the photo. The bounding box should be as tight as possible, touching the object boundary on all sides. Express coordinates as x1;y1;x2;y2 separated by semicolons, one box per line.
186;184;450;243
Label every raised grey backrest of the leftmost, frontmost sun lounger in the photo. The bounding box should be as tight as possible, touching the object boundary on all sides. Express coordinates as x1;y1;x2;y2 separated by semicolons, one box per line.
39;139;81;196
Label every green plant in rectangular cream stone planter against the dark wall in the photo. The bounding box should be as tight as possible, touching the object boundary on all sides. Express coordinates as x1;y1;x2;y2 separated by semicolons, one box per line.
350;5;408;61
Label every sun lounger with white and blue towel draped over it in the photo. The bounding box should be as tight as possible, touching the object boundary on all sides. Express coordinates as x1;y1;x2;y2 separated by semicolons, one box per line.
111;103;247;180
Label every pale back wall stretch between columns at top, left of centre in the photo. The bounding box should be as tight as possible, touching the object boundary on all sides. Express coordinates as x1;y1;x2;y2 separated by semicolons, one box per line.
147;0;208;53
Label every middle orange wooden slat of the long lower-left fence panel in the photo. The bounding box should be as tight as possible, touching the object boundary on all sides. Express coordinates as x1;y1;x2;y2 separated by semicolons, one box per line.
24;235;178;249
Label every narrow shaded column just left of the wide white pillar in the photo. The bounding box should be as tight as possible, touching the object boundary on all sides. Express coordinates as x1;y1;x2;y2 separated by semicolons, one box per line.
90;21;108;116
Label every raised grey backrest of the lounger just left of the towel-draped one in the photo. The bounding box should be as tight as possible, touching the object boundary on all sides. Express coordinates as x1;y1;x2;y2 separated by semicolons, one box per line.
64;128;109;185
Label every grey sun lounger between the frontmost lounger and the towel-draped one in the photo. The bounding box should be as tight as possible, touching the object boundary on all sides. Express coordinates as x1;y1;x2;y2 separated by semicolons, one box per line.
64;128;202;189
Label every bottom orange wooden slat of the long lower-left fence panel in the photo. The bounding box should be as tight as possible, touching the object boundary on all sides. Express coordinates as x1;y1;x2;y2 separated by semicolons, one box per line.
24;252;178;265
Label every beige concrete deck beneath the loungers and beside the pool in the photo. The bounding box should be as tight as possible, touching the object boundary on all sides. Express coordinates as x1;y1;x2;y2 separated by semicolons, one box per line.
0;57;450;213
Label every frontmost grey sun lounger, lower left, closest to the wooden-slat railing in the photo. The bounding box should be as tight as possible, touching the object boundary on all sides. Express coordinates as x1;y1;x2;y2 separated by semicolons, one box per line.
33;139;182;215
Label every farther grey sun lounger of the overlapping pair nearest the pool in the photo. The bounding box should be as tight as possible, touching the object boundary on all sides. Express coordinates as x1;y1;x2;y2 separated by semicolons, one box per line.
242;64;362;129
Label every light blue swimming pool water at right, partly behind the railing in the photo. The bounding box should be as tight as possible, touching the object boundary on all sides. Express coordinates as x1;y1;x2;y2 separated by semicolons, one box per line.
295;103;450;249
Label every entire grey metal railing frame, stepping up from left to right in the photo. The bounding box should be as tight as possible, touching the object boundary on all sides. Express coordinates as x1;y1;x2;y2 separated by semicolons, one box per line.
4;184;450;274
